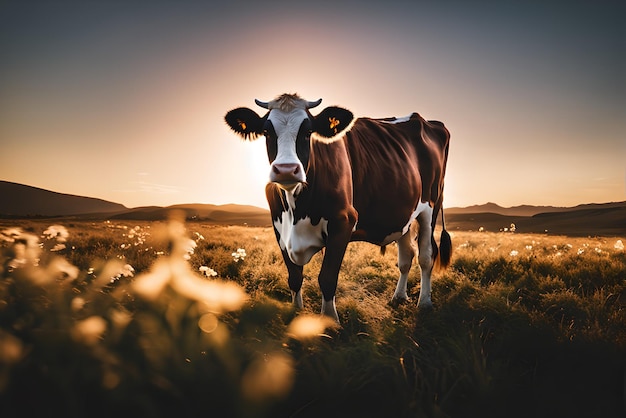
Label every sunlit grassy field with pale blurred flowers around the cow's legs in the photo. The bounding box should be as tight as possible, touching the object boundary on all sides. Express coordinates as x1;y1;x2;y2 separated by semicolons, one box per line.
0;220;626;418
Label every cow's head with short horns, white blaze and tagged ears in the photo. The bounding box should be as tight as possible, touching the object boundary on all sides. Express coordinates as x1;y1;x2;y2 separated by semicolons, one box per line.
225;94;353;190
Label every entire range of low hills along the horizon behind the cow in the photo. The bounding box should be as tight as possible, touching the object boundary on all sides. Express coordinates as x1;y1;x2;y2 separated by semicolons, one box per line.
0;181;626;237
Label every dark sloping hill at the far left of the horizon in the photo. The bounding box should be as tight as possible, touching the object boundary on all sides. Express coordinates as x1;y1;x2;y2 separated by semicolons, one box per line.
0;181;128;217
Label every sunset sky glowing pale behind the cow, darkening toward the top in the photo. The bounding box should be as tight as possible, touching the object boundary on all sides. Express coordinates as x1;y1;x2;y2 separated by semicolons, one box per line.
0;0;626;207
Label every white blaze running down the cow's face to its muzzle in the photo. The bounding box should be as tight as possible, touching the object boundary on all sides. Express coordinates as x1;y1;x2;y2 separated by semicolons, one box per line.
268;109;308;182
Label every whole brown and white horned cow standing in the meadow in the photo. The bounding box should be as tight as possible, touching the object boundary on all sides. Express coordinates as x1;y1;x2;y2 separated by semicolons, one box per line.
225;94;452;322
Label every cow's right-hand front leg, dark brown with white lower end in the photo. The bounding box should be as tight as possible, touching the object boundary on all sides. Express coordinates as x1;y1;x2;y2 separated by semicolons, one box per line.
318;215;356;322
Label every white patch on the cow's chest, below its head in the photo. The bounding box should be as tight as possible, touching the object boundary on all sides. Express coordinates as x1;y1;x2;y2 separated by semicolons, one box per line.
274;210;328;266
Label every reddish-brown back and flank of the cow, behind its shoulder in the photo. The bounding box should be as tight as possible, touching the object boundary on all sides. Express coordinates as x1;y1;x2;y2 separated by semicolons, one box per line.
344;113;449;244
